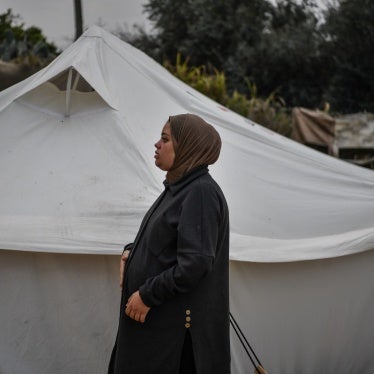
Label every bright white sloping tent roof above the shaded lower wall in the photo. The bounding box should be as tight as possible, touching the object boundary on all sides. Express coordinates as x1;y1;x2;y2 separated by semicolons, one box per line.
0;27;374;262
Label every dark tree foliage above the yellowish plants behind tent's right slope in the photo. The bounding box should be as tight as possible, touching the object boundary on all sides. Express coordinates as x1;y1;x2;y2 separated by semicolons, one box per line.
122;0;374;112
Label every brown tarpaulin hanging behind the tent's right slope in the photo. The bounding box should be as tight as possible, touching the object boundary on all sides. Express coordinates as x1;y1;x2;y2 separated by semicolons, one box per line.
292;108;335;155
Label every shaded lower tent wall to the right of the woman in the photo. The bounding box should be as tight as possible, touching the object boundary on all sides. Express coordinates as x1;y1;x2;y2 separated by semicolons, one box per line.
230;251;374;374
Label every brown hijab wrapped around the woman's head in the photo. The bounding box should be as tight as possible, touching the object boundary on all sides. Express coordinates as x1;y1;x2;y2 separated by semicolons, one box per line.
166;114;221;183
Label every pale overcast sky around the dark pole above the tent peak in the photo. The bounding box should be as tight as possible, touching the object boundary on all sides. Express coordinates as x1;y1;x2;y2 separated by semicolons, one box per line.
0;0;150;49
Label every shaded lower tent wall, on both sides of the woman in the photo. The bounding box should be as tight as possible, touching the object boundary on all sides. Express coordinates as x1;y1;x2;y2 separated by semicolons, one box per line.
0;251;374;374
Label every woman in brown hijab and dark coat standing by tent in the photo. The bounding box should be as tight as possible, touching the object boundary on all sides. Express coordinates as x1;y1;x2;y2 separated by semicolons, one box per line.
109;114;230;374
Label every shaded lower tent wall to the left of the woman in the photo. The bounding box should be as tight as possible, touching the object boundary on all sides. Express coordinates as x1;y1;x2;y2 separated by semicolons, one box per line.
0;251;120;374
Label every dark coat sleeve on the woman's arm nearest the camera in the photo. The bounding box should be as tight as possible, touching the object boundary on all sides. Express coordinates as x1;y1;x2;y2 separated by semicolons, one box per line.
139;182;221;307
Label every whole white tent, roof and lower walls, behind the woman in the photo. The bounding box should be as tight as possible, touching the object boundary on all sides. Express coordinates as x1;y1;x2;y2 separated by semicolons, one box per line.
0;27;374;374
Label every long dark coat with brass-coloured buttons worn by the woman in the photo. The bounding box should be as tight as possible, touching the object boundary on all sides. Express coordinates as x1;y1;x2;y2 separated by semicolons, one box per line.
111;167;230;374
